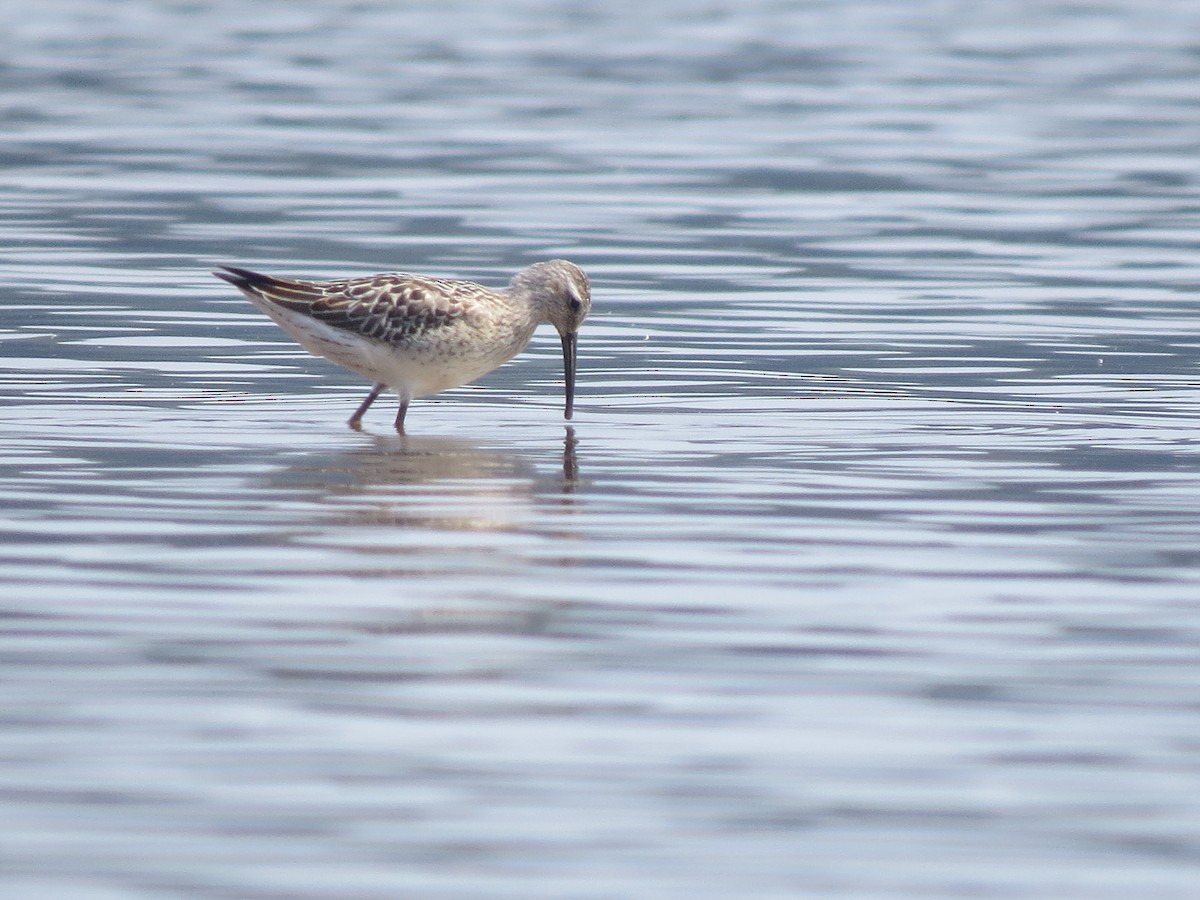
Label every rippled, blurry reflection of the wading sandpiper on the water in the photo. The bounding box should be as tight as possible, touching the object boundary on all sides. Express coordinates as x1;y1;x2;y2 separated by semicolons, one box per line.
260;426;583;638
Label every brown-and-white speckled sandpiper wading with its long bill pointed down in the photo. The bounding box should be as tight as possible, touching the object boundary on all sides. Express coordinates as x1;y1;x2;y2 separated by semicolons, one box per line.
212;259;592;434
